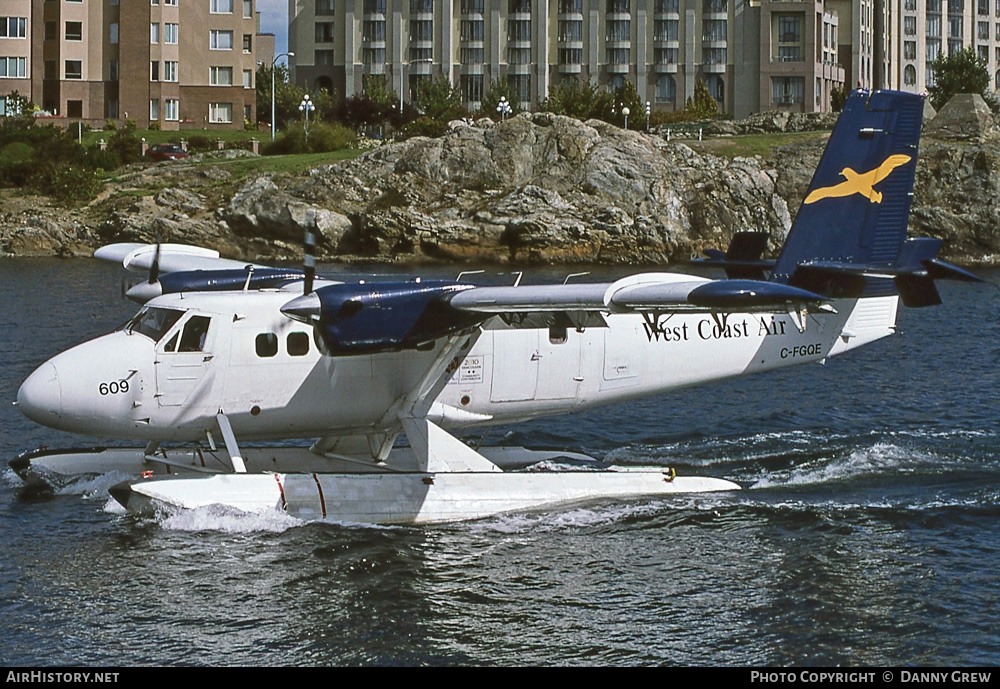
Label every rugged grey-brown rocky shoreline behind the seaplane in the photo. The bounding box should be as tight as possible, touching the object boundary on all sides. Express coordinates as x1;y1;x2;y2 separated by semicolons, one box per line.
0;99;1000;265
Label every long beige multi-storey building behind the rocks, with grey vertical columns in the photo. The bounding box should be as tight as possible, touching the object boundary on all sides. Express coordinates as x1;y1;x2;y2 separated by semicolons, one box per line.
289;0;850;116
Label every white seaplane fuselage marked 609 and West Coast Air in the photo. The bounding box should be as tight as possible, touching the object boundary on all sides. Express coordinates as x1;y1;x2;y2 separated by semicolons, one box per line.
18;282;897;441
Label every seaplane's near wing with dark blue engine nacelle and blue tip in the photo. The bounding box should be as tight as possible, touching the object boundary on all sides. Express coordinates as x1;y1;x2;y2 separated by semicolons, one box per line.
281;273;829;355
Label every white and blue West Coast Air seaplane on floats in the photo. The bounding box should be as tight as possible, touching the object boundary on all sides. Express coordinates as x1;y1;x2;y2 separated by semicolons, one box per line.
10;91;978;524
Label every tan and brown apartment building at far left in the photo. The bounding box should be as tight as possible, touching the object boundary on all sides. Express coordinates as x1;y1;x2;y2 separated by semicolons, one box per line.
0;0;259;129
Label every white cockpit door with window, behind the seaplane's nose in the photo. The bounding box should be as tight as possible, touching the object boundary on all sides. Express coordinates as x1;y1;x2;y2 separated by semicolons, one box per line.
156;314;217;407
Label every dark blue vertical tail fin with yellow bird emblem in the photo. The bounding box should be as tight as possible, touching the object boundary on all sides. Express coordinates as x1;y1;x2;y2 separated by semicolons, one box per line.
772;91;924;288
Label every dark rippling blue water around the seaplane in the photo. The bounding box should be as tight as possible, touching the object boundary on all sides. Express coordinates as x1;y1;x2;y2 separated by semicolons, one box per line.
0;259;1000;667
